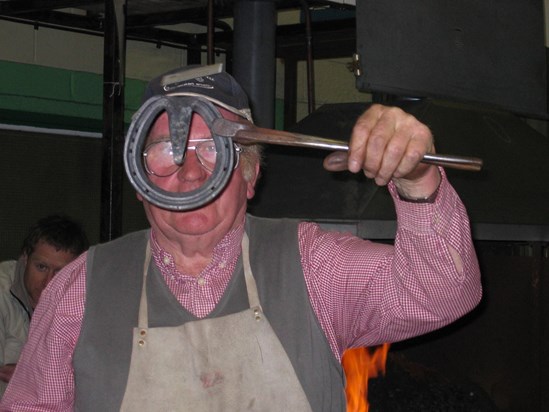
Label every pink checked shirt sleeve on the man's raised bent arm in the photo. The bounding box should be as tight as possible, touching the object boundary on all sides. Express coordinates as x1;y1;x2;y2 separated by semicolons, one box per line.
299;169;482;357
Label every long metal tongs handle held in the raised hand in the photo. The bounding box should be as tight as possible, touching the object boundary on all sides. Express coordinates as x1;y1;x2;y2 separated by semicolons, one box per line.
212;118;482;172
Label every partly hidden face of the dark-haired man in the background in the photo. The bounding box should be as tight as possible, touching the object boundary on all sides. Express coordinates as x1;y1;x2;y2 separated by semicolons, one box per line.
23;241;77;309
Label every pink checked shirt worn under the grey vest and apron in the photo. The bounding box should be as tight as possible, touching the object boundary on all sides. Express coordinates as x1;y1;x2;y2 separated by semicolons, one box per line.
0;176;481;411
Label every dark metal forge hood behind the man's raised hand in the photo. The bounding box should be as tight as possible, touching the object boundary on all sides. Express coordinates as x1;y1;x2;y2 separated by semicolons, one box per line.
250;99;549;241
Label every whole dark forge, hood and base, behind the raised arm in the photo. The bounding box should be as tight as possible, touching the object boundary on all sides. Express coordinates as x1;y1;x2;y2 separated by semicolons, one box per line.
251;100;549;412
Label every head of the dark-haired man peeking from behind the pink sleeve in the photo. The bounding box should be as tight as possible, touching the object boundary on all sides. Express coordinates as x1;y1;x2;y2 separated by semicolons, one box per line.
21;215;89;308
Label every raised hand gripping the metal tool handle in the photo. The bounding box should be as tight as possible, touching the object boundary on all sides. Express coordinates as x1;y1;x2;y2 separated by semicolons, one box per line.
324;104;440;199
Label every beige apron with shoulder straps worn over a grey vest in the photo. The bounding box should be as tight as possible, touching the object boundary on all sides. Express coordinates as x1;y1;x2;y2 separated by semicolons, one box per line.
121;234;311;412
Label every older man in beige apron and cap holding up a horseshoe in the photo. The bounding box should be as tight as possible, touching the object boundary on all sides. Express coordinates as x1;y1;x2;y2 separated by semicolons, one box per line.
1;68;481;411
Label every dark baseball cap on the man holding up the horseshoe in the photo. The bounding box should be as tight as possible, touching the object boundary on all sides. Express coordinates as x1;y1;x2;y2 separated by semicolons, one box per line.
143;63;253;122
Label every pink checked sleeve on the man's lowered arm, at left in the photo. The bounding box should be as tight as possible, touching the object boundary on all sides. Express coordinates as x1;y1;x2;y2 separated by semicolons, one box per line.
0;253;86;412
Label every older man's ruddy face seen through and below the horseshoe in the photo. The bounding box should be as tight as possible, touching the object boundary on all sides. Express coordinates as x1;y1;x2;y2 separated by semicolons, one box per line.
138;109;259;244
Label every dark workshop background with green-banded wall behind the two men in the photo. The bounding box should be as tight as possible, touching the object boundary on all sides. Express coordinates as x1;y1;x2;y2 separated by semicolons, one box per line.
0;0;549;412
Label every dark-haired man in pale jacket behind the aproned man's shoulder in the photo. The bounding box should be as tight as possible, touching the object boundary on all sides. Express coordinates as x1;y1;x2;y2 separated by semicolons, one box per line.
0;215;88;396
